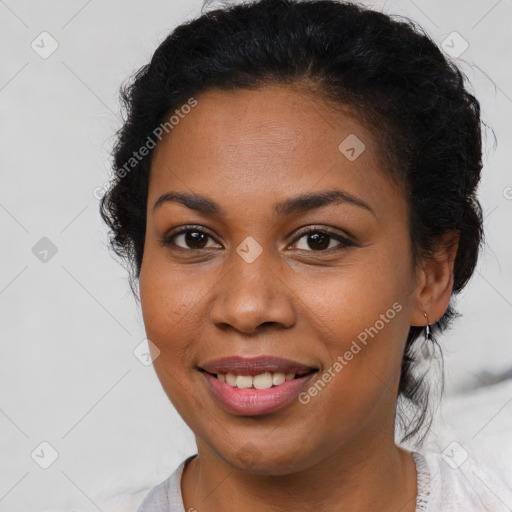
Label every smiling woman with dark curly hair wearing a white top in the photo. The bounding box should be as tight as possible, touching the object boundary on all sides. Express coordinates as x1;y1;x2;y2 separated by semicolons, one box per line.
101;0;511;512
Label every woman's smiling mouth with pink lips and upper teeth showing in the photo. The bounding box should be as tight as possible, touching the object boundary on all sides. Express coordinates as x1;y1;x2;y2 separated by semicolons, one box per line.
197;356;319;416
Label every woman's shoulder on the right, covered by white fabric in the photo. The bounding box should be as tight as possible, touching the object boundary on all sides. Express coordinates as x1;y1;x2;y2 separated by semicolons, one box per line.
415;448;512;512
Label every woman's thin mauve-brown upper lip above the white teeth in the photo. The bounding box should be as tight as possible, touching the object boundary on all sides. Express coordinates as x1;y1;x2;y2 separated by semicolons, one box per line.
200;356;318;376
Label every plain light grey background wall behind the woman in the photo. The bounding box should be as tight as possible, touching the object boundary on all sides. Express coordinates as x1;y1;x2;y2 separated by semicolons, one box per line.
0;0;512;512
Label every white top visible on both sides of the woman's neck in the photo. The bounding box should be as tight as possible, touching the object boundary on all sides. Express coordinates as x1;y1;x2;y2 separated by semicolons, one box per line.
137;450;512;512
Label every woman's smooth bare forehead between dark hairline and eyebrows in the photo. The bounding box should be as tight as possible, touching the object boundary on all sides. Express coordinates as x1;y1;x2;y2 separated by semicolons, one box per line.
150;85;402;218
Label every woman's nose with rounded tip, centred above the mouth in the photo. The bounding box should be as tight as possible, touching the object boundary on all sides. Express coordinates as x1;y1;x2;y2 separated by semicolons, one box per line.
209;245;296;334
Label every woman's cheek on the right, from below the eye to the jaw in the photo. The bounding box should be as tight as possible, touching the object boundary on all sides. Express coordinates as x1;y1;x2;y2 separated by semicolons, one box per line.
298;247;409;414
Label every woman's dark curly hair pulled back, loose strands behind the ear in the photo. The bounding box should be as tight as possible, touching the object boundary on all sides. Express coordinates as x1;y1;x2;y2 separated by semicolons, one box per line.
100;0;483;441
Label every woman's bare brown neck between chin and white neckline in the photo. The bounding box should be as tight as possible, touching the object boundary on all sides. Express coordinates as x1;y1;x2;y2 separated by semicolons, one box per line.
182;428;417;512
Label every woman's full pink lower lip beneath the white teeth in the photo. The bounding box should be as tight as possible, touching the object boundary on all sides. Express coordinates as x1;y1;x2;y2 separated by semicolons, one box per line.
201;372;315;416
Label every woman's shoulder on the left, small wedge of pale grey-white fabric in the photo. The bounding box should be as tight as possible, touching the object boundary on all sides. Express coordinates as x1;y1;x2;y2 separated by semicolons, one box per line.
137;455;196;512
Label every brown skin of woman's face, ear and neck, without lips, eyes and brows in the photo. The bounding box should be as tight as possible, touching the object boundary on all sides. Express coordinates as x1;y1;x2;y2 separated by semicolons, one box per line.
140;85;456;512
